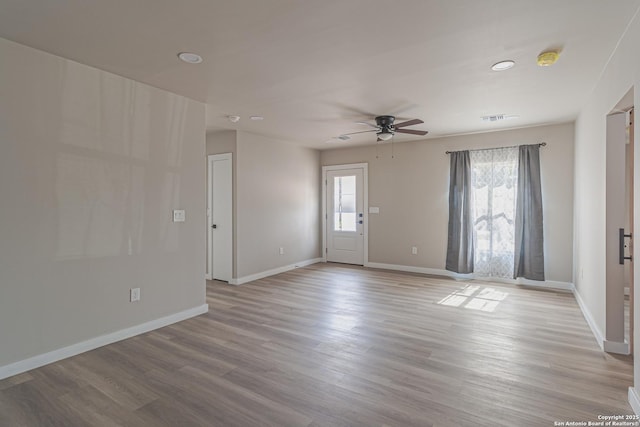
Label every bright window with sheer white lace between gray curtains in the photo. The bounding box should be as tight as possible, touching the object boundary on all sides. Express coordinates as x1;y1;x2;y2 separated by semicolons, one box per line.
470;147;518;277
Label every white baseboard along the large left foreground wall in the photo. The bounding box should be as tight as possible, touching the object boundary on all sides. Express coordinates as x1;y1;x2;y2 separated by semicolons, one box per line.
0;304;209;380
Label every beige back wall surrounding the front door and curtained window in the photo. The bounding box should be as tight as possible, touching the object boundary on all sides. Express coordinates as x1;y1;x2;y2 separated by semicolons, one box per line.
321;124;573;282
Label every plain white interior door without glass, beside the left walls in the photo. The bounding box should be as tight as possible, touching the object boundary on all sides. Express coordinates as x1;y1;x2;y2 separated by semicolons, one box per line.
208;154;233;282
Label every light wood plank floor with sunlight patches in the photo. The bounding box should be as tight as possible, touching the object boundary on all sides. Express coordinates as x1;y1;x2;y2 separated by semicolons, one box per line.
0;264;633;426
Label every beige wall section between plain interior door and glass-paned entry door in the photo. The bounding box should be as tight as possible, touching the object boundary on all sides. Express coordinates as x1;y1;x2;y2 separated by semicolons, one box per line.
235;131;321;278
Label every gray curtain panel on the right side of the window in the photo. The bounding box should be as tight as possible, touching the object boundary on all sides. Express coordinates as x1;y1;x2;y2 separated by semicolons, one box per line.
513;144;544;280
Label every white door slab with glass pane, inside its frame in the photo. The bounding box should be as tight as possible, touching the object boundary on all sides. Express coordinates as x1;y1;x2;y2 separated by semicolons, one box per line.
326;168;364;265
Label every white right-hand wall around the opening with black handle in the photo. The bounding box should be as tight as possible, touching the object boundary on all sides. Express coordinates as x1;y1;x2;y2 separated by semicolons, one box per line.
574;10;640;404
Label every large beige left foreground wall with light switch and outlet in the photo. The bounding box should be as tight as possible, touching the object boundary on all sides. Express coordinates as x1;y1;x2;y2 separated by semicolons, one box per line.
0;39;205;368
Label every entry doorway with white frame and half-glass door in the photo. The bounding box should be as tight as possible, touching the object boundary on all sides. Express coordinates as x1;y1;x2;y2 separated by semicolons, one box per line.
322;163;369;265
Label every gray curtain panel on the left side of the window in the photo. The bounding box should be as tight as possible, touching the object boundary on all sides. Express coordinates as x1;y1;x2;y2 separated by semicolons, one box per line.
446;151;473;273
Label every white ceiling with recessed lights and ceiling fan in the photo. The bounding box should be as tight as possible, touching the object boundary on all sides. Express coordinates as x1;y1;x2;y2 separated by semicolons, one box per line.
0;0;640;149
